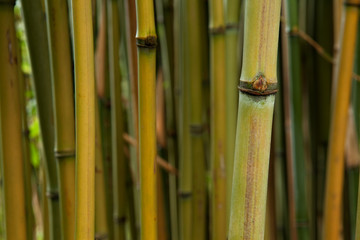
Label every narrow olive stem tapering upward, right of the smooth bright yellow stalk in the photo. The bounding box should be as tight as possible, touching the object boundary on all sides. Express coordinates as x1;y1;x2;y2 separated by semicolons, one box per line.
95;102;109;239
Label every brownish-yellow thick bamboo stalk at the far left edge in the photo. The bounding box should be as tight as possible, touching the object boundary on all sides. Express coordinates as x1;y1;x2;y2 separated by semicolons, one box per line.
0;1;26;240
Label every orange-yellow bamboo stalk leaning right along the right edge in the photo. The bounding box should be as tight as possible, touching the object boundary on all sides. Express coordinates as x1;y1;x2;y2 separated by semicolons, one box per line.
324;0;360;240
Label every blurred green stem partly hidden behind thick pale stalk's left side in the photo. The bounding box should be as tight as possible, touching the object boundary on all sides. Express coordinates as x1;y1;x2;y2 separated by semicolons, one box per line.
225;0;241;229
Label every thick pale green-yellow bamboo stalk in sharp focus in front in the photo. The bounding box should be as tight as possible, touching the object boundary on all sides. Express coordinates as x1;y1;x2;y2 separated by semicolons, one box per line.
228;0;281;240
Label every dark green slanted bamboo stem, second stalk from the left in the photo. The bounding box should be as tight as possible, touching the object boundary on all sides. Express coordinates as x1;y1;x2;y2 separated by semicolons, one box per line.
21;0;61;237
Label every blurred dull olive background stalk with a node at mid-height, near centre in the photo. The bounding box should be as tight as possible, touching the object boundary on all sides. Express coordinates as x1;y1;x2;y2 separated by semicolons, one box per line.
184;0;207;239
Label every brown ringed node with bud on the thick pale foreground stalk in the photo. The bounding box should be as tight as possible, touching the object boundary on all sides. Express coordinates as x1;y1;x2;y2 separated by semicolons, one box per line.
238;74;278;96
